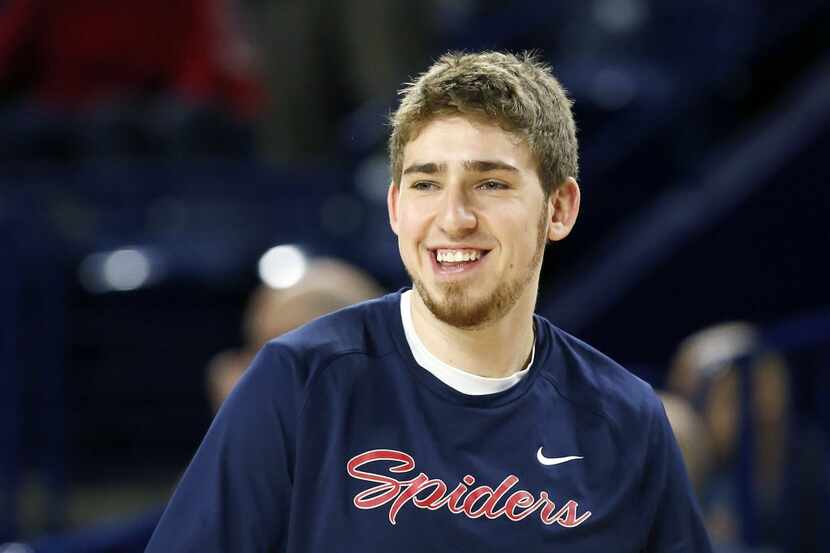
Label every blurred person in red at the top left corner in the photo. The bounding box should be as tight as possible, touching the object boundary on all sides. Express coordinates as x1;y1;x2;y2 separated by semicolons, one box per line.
0;0;262;159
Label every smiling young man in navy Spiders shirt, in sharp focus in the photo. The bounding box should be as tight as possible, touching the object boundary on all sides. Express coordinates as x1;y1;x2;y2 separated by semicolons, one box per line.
147;53;710;553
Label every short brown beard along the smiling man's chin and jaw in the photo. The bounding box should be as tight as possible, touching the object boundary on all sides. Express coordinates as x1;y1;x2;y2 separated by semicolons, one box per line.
407;207;548;330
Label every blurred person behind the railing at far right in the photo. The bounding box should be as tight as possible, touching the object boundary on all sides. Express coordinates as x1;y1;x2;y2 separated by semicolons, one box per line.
667;322;827;552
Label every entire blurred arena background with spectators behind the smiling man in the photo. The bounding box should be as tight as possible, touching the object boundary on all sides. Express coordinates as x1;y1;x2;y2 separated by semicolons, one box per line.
0;0;830;553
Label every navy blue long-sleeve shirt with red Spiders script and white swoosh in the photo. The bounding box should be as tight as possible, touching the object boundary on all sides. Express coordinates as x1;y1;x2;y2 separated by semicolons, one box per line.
147;293;711;553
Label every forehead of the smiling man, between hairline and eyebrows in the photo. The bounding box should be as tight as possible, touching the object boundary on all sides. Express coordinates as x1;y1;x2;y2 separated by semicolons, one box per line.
403;115;536;171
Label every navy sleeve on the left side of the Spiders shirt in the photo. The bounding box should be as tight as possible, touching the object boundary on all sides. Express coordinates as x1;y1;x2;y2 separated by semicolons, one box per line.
146;344;299;553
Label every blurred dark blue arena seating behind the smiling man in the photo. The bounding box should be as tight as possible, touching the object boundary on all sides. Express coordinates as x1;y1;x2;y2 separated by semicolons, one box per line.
0;0;830;553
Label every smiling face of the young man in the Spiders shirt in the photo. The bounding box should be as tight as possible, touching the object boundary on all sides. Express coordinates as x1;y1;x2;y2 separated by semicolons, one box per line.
389;116;560;328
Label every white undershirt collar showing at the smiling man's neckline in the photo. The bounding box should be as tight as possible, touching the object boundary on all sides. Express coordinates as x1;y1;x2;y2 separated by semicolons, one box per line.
401;290;536;396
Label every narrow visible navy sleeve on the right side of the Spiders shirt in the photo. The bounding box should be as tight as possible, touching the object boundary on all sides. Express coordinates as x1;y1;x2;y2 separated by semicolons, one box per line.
643;396;712;553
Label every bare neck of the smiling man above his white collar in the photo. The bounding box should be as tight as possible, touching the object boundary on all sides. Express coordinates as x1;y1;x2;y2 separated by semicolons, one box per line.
412;283;537;378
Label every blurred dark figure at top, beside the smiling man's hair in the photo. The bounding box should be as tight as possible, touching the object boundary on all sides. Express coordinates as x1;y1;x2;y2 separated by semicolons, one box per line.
242;0;439;161
